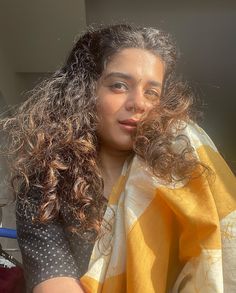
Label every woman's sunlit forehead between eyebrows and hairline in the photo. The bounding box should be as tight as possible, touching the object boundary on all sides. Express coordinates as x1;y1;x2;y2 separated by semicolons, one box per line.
102;48;165;78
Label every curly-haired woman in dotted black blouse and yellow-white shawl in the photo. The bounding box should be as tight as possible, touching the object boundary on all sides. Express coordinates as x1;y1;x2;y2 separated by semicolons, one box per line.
2;24;236;293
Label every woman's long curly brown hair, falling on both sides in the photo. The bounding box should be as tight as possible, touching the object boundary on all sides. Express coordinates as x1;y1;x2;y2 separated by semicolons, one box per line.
0;24;204;234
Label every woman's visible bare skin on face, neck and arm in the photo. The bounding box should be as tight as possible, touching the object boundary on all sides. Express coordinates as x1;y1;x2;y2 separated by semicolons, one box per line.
33;48;164;293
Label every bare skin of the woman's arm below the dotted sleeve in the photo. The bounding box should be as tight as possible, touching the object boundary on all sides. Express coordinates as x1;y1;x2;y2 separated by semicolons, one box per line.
33;277;85;293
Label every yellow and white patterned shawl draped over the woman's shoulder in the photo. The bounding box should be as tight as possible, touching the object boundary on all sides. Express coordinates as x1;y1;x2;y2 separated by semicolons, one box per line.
80;124;236;293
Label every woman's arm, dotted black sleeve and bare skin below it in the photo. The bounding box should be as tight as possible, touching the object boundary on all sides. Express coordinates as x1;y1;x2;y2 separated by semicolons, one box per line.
16;186;88;293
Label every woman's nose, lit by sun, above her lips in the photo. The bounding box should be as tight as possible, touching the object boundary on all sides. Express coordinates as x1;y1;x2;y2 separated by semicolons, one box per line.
126;89;147;113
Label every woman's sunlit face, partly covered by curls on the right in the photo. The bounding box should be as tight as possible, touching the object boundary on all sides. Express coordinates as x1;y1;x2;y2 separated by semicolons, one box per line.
96;48;164;151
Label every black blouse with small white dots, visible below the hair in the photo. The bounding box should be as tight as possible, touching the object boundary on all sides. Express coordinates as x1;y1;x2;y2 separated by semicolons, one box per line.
16;189;93;290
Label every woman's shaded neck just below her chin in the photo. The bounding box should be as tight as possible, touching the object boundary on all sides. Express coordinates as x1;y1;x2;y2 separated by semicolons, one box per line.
99;146;132;181
